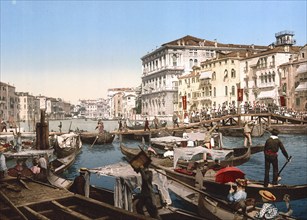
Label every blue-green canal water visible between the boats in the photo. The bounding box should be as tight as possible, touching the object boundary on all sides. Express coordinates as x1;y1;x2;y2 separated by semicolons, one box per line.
44;119;307;219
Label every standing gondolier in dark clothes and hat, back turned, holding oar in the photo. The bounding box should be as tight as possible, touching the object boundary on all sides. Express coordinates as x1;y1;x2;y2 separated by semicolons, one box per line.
264;129;290;187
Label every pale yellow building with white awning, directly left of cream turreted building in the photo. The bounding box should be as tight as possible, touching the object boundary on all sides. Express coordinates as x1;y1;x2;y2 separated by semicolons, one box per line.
200;51;249;112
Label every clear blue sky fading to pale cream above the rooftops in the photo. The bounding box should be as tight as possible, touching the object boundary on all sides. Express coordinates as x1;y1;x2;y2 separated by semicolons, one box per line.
0;0;307;104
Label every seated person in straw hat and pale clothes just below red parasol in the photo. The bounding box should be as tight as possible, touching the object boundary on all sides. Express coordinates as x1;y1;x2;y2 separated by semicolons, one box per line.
227;178;247;211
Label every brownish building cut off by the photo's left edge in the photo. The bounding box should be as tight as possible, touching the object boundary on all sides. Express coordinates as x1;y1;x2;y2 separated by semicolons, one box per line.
0;82;19;127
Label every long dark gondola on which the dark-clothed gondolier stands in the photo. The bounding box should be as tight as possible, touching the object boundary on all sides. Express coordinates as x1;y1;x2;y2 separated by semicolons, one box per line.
120;144;307;202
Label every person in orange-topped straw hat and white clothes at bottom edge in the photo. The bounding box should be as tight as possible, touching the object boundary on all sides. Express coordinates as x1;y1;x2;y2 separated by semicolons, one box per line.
255;190;278;219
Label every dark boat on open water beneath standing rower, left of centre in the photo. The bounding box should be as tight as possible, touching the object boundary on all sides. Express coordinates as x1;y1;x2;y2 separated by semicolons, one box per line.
80;131;115;145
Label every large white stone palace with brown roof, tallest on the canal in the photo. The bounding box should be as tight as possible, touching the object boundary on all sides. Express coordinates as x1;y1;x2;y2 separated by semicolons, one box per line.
141;35;267;119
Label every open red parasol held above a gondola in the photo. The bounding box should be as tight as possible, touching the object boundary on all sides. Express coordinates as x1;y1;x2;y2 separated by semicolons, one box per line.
215;167;245;183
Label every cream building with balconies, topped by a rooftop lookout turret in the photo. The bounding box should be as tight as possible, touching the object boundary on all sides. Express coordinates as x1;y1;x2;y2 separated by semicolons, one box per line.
240;31;299;106
